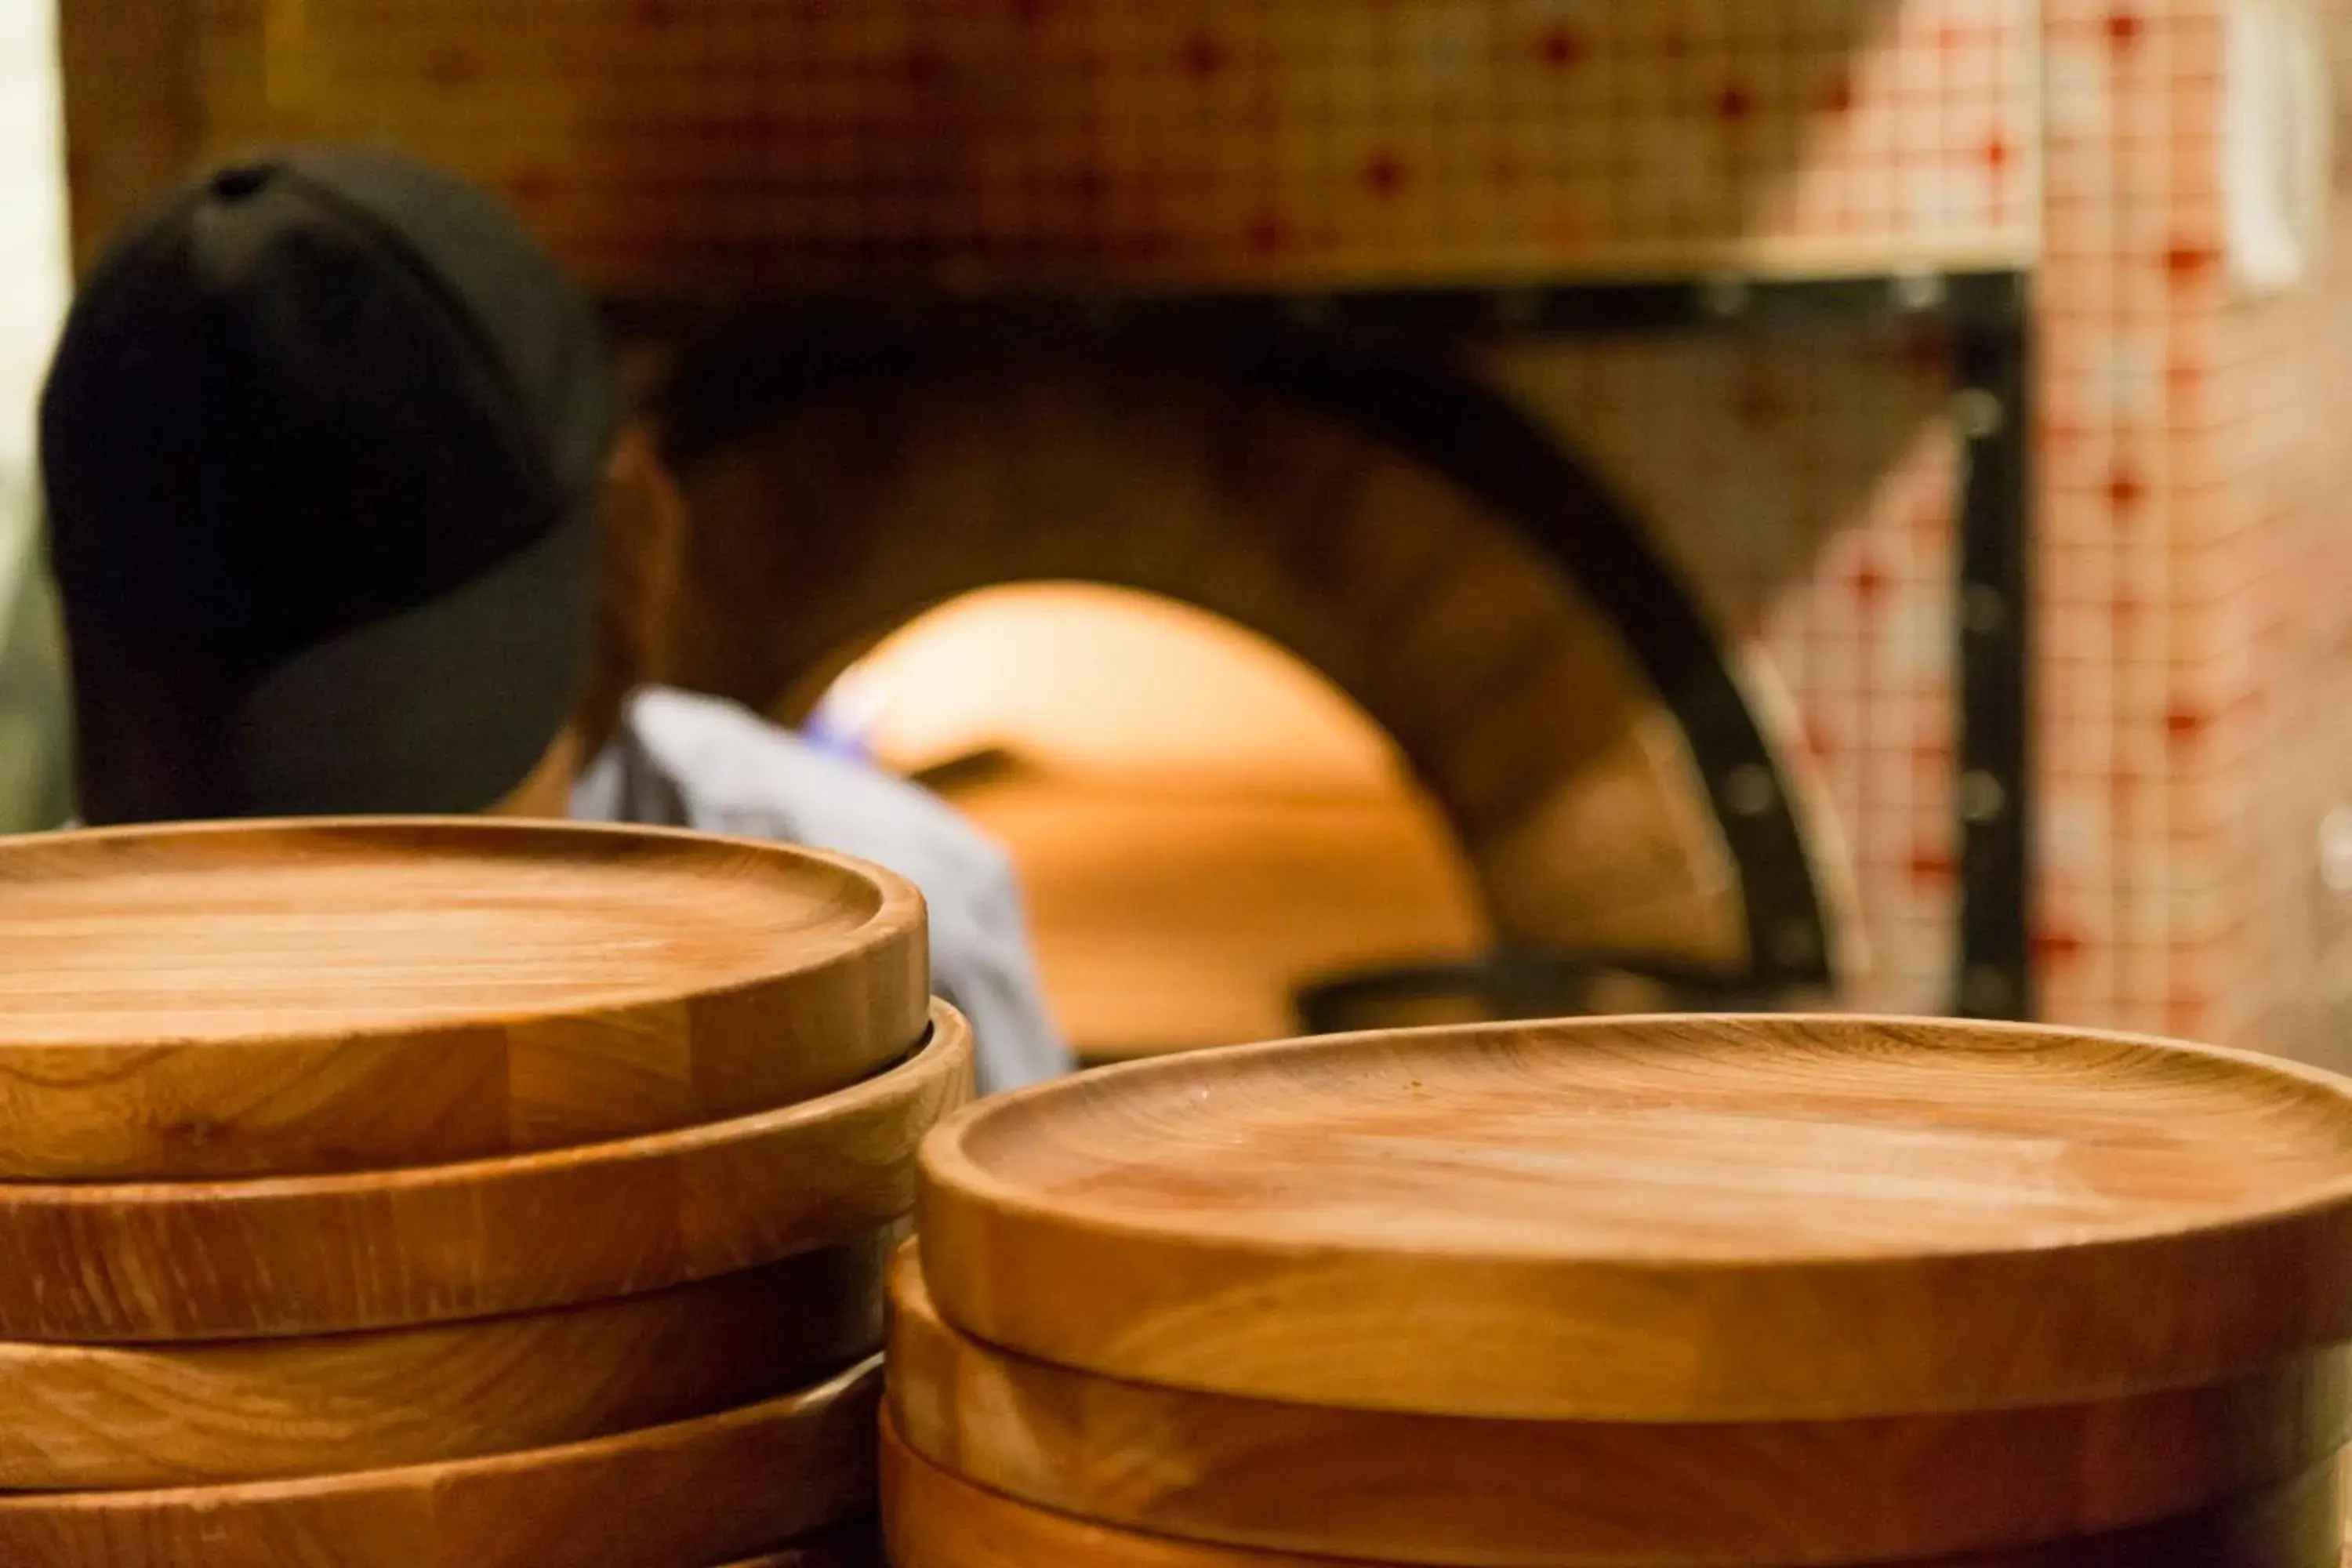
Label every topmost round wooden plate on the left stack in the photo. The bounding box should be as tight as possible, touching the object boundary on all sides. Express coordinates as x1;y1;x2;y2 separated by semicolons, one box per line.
0;818;931;1180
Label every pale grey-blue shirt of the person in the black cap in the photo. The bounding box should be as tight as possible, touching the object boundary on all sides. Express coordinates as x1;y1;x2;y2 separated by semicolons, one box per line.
572;687;1070;1093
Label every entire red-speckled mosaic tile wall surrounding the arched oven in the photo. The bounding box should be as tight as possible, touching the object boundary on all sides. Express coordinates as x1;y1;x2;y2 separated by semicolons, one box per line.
64;0;2352;1058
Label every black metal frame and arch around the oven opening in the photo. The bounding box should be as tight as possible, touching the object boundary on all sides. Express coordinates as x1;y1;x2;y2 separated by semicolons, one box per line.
612;270;2034;1018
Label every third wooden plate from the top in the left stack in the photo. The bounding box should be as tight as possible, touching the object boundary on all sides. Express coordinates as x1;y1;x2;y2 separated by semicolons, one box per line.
0;1227;896;1490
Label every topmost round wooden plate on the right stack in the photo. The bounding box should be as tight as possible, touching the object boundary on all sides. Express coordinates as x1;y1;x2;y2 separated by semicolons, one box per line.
917;1018;2352;1422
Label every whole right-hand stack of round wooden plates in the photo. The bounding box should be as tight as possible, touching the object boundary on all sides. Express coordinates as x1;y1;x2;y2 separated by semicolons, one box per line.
884;1018;2352;1568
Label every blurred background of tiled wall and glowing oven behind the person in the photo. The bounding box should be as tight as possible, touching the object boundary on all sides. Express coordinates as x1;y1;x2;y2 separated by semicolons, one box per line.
13;0;2352;1065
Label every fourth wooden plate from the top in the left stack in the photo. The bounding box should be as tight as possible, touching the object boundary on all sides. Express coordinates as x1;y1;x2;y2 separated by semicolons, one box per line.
0;1356;882;1568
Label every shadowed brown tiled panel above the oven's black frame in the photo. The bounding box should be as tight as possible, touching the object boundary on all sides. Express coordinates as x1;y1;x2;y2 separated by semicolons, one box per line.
161;0;2039;289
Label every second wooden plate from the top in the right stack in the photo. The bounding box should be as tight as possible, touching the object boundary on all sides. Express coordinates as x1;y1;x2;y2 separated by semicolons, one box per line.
889;1248;2352;1568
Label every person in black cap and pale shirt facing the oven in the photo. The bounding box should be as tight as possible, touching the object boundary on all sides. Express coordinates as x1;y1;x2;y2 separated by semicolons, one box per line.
40;148;1070;1091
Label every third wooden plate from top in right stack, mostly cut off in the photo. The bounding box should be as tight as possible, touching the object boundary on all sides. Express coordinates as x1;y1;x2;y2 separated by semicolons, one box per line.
882;1415;2343;1568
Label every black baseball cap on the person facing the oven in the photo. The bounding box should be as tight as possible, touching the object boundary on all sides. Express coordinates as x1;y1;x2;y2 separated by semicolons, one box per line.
40;148;616;820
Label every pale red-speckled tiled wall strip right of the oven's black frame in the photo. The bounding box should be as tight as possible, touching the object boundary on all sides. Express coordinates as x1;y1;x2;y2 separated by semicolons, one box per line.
2037;0;2352;1065
